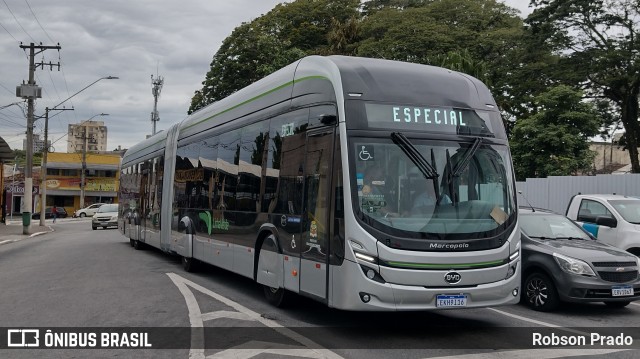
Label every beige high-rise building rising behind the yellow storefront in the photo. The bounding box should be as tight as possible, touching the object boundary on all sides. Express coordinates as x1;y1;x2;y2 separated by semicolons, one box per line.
67;121;107;153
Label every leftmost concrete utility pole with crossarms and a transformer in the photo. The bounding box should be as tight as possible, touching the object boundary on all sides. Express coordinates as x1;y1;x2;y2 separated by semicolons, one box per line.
16;42;61;234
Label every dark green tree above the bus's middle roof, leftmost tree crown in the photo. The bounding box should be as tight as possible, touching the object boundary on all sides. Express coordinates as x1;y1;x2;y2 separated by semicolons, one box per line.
189;0;360;113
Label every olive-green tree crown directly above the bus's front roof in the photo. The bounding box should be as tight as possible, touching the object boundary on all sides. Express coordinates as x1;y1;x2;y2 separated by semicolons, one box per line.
357;0;524;121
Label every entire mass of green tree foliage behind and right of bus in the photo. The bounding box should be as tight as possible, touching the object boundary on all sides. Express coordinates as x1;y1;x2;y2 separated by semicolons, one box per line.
189;0;640;178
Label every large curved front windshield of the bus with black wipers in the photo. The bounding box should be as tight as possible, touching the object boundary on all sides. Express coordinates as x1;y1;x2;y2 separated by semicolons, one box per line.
351;136;517;239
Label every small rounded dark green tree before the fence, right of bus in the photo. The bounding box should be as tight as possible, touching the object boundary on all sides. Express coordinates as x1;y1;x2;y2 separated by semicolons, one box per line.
511;85;600;180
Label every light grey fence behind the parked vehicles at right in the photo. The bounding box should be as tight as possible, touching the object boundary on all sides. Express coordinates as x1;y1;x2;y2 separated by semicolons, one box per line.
516;174;640;214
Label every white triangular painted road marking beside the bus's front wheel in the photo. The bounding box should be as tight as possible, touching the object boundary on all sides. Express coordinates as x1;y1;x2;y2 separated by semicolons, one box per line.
167;273;343;359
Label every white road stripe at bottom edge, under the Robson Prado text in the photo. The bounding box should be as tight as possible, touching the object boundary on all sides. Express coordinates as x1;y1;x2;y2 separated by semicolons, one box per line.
422;349;631;359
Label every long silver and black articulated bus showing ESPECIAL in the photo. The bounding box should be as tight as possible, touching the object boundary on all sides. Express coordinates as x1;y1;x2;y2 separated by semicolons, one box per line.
118;56;520;311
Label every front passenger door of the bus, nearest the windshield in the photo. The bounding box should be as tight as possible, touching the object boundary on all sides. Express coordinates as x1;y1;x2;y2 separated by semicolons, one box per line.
299;127;335;302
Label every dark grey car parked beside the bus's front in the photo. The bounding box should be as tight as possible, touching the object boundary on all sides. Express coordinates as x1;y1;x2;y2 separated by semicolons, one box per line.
519;208;640;311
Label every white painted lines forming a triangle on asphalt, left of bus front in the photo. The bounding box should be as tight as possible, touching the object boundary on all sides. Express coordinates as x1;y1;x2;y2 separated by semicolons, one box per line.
167;273;344;359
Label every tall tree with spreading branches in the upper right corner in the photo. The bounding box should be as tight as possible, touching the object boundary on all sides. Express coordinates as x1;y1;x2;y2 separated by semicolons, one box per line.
527;0;640;173
